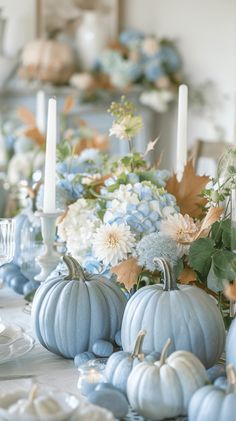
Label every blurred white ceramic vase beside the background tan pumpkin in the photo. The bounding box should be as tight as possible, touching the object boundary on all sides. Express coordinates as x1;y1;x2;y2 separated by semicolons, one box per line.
76;10;110;71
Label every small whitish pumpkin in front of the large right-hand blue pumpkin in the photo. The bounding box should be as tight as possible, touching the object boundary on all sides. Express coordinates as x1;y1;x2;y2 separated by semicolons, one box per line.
127;339;208;421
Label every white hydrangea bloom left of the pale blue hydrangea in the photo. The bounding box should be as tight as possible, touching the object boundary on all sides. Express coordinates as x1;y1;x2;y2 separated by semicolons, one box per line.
58;199;101;262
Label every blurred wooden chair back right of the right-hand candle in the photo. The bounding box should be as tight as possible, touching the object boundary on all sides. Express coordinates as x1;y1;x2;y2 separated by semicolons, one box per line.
189;139;229;170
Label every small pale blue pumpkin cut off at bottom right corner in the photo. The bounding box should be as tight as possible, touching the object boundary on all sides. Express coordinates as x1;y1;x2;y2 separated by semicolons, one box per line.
188;365;236;421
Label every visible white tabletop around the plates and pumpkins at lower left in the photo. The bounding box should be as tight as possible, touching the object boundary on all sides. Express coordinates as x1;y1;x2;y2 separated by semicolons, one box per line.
0;286;187;421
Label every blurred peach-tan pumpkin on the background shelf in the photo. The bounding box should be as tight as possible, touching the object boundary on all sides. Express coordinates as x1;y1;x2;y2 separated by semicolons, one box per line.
20;39;75;84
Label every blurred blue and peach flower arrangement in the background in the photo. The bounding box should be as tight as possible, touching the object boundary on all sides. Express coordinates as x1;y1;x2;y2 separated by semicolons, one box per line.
71;31;182;112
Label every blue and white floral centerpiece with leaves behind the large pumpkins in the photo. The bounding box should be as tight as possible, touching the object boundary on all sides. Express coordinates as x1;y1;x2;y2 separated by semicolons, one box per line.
58;98;236;316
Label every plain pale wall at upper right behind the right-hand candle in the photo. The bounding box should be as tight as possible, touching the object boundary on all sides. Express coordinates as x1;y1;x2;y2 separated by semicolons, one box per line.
121;0;236;168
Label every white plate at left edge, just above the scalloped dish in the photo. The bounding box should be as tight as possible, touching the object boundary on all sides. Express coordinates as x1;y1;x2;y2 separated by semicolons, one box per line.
0;332;34;364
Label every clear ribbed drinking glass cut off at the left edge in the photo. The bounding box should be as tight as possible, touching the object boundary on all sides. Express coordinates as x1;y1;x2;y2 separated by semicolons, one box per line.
0;218;15;266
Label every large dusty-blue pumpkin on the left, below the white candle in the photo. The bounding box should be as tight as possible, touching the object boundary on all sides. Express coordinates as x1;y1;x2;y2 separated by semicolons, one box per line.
32;256;126;358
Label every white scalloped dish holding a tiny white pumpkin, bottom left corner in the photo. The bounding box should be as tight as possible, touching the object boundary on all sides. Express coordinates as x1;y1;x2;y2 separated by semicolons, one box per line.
0;390;79;421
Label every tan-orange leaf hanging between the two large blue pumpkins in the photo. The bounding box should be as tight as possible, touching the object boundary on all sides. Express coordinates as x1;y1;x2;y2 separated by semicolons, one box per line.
111;257;142;291
